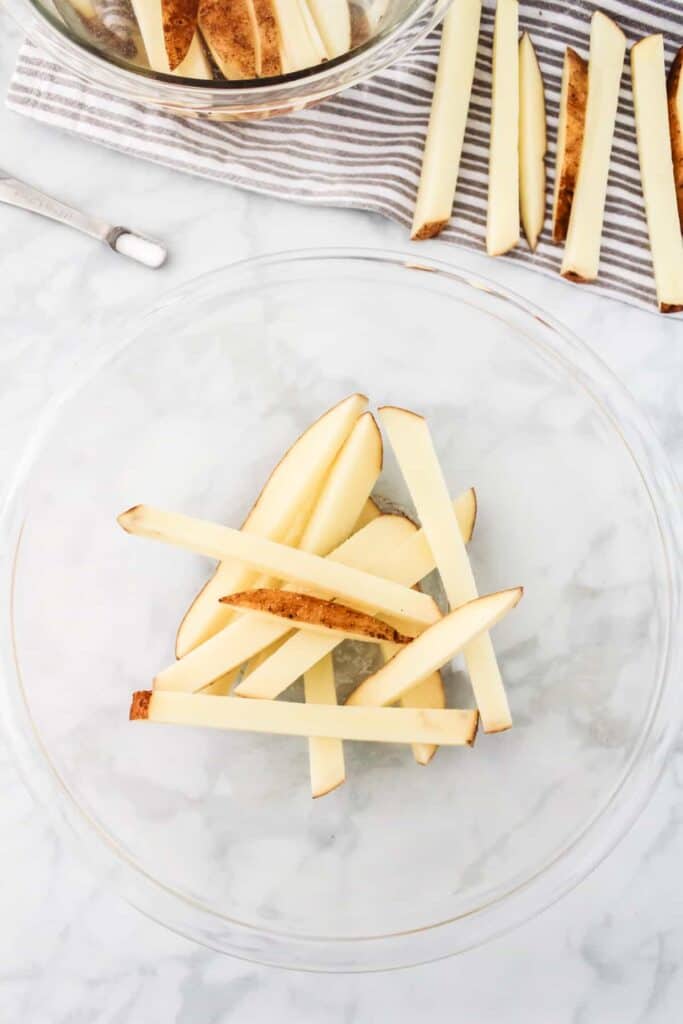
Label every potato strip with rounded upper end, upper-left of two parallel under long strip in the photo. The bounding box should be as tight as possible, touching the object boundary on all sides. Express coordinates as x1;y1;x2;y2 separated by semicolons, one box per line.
154;516;419;692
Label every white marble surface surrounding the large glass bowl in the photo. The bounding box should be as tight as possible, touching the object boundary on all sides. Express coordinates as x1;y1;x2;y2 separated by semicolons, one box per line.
0;9;683;1024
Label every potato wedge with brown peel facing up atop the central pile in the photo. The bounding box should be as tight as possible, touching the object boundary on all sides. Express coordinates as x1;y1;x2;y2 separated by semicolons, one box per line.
221;589;412;644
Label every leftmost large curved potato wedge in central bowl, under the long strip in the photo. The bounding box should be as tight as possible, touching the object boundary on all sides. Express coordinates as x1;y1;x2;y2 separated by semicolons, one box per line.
175;394;368;657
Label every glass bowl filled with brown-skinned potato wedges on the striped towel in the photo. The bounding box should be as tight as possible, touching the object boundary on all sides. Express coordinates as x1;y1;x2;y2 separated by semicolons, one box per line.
7;0;454;120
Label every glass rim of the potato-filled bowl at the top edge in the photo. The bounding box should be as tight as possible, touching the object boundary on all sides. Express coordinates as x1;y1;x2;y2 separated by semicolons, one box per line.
5;0;453;105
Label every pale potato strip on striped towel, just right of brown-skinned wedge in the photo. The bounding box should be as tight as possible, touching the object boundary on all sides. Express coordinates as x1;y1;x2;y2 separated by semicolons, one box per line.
561;10;626;283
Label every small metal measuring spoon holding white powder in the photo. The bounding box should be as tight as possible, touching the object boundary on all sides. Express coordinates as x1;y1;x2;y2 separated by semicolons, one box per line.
0;170;167;268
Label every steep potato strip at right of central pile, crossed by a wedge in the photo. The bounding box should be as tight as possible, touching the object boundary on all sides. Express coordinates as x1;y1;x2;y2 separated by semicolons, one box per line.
380;407;512;732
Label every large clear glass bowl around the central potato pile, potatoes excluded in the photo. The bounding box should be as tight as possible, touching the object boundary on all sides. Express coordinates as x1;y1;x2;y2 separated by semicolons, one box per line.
0;251;683;971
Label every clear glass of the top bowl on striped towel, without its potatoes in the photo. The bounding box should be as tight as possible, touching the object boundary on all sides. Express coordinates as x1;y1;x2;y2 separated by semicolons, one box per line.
2;0;451;120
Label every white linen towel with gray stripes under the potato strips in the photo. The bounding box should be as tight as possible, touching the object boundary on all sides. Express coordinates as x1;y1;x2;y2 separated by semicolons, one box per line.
7;0;683;310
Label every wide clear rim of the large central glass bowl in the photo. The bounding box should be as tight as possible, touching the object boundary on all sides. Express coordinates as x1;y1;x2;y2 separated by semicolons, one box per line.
0;248;683;973
